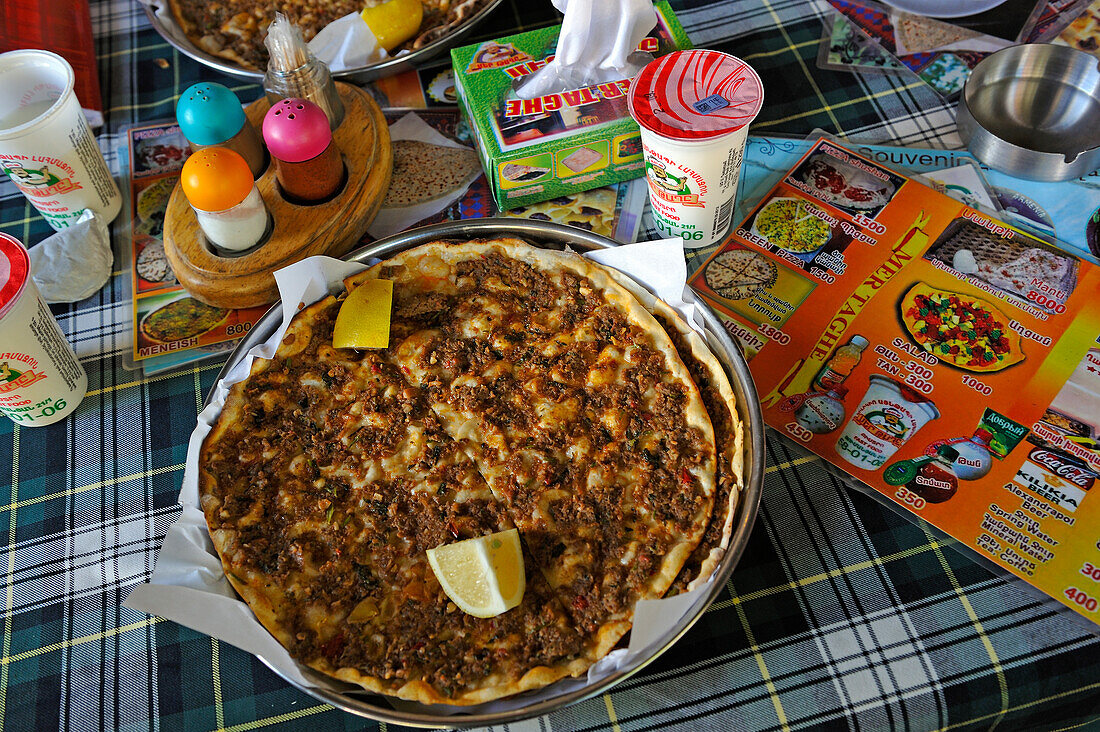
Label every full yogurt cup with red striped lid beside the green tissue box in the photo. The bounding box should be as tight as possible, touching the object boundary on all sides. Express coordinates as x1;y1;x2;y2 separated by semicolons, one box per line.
628;50;763;249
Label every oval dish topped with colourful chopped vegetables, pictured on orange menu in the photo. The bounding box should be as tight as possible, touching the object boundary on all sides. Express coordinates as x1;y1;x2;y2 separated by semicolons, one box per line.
899;282;1024;372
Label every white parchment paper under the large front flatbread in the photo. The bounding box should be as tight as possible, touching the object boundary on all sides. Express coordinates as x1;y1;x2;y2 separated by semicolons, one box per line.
123;239;726;714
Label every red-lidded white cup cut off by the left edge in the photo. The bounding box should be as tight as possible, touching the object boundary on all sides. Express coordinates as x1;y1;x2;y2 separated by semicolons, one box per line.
0;232;88;427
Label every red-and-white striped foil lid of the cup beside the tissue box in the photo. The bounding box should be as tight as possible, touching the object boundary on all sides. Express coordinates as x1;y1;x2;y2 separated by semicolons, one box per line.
629;48;763;141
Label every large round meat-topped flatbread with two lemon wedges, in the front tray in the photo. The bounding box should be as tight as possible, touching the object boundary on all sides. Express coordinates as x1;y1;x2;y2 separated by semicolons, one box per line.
198;238;744;706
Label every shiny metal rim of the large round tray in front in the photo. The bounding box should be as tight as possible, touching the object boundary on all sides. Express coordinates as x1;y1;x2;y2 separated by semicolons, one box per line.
207;219;765;728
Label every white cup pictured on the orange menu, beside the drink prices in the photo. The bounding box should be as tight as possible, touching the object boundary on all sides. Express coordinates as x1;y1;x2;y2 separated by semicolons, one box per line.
836;373;939;470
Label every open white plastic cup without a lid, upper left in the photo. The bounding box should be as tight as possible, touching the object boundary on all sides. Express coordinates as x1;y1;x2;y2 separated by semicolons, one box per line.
0;50;122;231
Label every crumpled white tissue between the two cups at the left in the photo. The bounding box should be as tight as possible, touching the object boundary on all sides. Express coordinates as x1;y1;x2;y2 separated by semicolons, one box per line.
28;208;114;303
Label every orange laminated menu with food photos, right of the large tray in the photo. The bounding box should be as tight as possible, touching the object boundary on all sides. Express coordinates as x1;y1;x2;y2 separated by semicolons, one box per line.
689;139;1100;622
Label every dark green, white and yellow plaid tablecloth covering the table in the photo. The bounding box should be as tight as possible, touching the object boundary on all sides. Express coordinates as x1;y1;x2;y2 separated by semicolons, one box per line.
0;0;1100;732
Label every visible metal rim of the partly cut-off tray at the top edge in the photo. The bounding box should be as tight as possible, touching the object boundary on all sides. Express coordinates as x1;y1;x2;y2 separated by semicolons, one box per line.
142;0;503;84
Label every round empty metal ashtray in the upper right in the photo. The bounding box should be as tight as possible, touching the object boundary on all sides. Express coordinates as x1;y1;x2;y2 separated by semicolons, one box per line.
956;43;1100;181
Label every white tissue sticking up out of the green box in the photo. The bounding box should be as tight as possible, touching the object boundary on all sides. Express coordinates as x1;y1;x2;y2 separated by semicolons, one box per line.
516;0;657;99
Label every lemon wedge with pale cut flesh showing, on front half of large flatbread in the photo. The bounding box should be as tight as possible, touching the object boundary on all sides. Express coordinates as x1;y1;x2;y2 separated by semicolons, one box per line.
428;528;527;618
